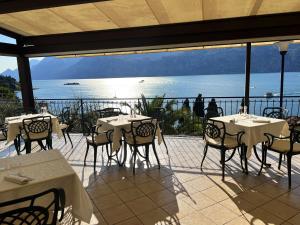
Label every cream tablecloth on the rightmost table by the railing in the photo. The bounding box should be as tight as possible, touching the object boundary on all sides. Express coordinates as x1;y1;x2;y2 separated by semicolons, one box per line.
211;114;289;158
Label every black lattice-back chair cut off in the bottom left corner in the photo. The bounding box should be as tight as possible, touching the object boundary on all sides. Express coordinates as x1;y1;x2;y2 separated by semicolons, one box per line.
0;188;65;225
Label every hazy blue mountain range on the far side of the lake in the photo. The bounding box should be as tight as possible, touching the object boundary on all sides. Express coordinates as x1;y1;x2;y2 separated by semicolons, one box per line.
3;44;300;80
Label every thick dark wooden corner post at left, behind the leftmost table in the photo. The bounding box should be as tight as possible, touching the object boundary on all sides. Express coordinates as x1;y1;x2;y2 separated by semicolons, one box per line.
17;55;35;112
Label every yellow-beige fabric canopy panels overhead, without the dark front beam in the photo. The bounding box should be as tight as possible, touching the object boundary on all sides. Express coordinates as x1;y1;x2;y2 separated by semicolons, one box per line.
0;0;300;36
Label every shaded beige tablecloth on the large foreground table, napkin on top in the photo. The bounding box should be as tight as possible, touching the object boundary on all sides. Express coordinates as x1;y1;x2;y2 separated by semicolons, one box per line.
0;150;93;222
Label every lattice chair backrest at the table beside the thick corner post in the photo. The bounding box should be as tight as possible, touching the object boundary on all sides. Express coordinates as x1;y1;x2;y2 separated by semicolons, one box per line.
23;116;52;140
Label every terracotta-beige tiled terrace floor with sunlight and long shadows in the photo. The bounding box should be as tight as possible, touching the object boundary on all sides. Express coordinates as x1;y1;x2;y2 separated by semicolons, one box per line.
0;134;300;225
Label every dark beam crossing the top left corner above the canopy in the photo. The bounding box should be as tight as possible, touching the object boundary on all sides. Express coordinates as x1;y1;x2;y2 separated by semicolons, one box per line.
0;0;110;14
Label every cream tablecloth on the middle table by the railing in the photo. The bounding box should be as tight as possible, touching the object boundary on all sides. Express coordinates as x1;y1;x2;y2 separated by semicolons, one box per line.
97;115;162;151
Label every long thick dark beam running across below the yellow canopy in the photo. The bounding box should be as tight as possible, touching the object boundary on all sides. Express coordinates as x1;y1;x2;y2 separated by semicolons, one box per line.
23;12;300;49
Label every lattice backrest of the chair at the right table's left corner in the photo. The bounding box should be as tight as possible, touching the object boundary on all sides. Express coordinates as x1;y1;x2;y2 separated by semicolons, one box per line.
204;119;226;145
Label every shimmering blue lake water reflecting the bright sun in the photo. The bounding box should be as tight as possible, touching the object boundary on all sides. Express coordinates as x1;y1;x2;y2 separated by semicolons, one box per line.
21;73;300;99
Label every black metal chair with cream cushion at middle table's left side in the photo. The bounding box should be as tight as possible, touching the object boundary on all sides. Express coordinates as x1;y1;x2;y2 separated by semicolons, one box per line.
84;126;113;171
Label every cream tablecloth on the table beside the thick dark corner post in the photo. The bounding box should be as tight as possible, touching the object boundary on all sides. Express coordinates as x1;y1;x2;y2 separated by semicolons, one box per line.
5;113;63;142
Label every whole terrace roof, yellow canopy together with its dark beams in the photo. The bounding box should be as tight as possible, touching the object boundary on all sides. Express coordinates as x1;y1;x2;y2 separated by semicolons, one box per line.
0;0;300;56
